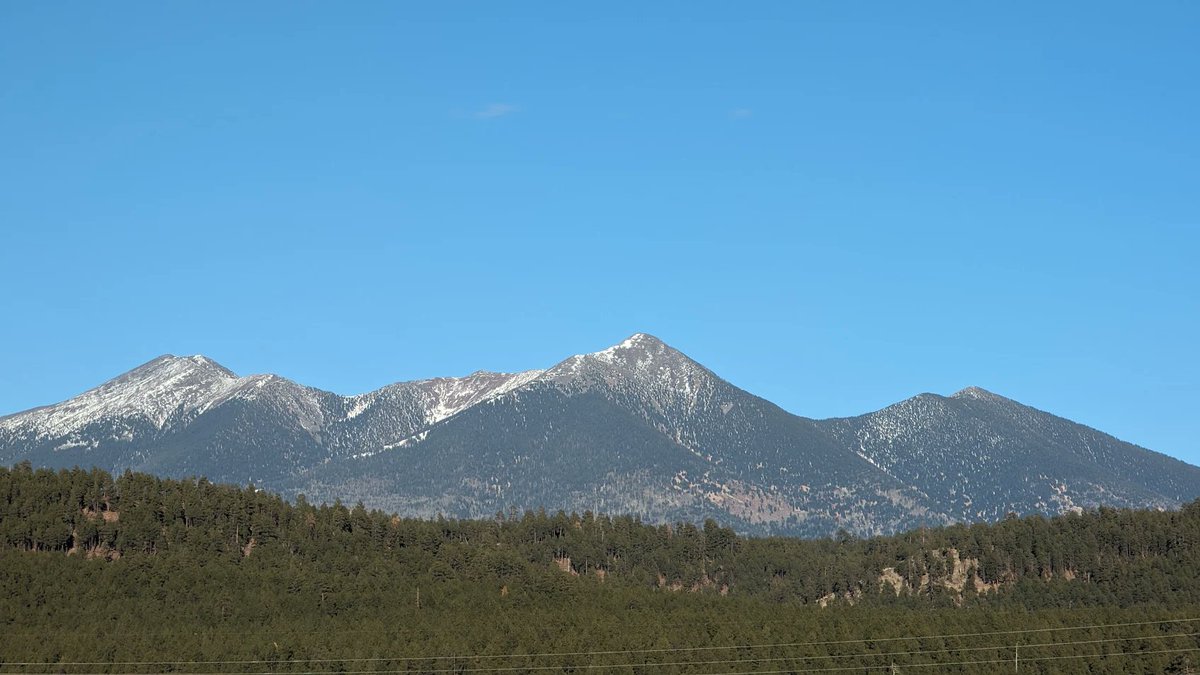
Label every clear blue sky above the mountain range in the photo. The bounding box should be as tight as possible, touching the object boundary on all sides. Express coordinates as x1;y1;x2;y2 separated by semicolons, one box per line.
0;1;1200;464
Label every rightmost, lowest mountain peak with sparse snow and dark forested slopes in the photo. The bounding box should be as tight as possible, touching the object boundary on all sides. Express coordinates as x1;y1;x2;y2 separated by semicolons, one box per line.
821;387;1200;521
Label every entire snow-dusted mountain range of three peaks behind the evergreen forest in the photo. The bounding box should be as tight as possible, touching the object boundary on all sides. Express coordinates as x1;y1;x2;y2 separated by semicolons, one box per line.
0;333;1200;536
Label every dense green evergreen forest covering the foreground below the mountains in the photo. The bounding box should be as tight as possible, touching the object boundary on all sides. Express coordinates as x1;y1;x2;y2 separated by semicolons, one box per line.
0;464;1200;675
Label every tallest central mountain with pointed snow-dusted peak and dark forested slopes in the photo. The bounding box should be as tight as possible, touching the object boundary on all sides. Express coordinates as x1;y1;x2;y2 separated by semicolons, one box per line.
298;334;940;533
